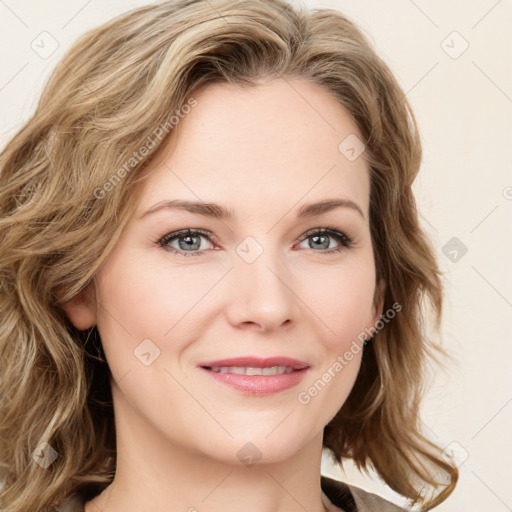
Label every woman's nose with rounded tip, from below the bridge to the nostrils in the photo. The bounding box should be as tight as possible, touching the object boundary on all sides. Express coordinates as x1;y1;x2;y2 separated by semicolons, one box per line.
227;244;298;332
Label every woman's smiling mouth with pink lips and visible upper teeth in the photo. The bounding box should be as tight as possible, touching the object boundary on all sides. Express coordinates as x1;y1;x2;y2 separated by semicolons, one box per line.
199;357;310;396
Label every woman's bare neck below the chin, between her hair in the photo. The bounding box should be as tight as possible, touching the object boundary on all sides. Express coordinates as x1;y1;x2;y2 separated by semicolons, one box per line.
85;388;332;512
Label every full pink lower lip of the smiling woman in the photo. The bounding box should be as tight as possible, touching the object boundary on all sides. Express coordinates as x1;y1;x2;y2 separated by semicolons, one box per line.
201;368;309;396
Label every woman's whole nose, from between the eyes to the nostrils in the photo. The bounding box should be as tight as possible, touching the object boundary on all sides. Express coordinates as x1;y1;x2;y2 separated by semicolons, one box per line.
228;237;296;330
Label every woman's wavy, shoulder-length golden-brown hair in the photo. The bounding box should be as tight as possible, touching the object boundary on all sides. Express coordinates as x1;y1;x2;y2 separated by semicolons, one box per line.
0;0;458;512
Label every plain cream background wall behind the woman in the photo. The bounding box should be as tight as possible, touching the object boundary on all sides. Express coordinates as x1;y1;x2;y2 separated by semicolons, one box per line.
0;0;512;512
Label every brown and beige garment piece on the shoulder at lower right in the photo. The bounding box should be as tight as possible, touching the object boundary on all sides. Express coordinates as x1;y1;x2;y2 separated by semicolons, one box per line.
321;475;407;512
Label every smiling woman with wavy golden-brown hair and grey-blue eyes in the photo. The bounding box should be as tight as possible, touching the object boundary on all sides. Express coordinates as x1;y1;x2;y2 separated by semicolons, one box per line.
0;0;458;512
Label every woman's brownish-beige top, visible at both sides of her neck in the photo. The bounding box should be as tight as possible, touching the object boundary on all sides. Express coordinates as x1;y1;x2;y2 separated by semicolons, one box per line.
50;475;407;512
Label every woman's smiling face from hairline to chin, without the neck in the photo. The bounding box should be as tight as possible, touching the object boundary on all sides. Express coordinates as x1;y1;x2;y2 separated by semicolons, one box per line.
67;80;382;463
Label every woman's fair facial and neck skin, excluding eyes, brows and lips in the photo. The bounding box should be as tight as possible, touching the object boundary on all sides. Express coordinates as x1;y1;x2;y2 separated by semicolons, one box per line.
65;79;382;512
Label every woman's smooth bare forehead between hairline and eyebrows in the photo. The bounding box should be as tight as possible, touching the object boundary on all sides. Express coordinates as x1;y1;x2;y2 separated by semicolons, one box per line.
139;79;369;217
